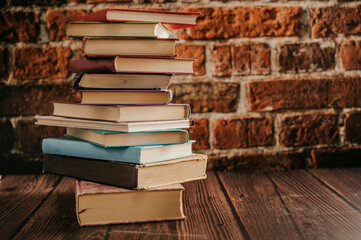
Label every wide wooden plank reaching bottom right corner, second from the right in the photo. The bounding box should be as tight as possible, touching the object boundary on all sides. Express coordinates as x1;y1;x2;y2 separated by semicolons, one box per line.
269;170;361;239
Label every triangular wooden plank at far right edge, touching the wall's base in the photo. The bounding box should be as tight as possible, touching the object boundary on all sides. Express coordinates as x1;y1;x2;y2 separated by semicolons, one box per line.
310;168;361;210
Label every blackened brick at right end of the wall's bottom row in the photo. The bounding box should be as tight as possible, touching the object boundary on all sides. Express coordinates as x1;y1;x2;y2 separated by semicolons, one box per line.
311;148;361;168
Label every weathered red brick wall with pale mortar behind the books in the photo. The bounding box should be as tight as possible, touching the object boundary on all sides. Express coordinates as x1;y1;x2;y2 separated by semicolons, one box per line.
0;0;361;170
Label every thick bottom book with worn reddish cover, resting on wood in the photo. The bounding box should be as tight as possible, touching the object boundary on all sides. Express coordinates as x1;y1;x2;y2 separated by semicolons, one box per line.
75;181;185;226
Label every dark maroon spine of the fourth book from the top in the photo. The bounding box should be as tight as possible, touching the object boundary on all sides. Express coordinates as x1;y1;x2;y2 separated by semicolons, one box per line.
69;58;116;73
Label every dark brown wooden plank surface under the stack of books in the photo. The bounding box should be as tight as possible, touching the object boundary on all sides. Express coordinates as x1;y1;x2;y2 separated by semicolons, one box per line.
0;169;361;239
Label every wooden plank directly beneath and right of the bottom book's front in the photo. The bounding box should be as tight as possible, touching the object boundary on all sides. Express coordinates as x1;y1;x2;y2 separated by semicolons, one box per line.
109;172;244;239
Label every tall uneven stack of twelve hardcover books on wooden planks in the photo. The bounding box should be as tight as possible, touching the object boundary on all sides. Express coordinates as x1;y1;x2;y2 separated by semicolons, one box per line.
36;9;207;226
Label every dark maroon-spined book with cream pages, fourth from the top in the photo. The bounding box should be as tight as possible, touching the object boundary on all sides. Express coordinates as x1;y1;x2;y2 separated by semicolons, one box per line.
69;57;194;74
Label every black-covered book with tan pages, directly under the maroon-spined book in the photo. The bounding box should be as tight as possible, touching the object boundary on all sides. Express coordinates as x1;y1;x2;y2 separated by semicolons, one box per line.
72;72;173;90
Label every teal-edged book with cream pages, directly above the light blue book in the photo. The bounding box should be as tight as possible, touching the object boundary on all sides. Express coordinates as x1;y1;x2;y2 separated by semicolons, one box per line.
66;128;189;147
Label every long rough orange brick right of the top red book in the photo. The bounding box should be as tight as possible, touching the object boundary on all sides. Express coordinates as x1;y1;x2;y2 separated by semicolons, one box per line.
179;6;302;39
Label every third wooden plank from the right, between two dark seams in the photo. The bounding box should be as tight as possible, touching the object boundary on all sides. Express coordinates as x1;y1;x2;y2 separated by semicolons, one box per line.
217;172;302;239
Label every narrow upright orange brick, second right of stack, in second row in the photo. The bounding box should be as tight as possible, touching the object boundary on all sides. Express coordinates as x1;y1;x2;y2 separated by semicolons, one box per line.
212;44;232;76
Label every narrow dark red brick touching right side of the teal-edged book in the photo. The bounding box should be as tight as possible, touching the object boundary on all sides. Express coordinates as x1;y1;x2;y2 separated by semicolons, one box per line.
188;118;209;150
